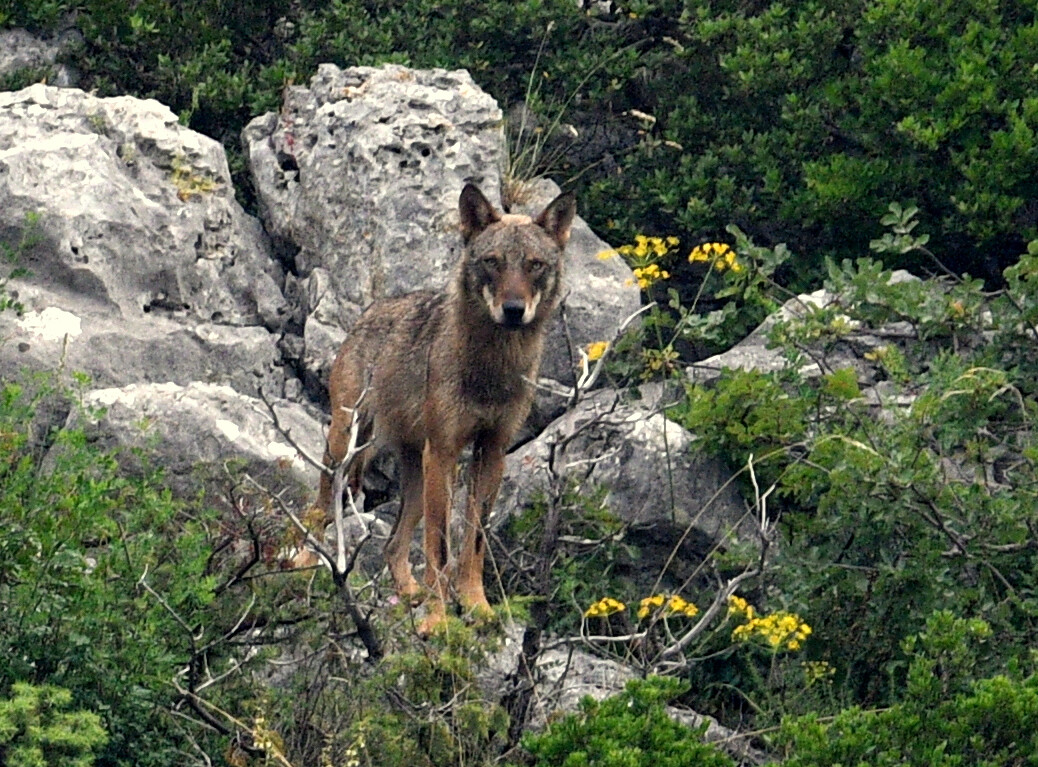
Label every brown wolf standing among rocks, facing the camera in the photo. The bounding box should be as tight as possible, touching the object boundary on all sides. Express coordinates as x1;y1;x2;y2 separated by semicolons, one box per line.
318;184;576;634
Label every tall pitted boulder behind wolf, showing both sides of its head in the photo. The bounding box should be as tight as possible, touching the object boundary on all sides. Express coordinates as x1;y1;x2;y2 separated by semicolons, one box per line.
243;64;639;390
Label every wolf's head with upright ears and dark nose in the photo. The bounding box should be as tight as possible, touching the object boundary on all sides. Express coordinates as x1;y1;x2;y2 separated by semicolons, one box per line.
459;184;576;329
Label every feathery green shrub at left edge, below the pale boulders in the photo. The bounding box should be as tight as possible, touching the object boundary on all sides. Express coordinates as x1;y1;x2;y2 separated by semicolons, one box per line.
0;376;282;767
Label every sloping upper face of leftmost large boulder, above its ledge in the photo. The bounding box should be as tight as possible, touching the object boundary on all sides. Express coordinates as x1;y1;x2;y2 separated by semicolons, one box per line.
0;85;285;330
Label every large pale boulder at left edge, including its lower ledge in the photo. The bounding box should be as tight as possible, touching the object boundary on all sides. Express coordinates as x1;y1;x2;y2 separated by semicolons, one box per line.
0;84;290;395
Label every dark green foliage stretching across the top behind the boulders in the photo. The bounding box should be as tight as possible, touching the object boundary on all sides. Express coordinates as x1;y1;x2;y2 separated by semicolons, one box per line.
0;0;1038;285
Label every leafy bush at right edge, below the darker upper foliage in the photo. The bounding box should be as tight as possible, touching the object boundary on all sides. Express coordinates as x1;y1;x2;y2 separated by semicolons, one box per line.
675;217;1038;714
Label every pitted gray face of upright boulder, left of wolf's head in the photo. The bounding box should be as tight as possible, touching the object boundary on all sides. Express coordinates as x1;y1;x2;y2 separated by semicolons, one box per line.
244;64;502;308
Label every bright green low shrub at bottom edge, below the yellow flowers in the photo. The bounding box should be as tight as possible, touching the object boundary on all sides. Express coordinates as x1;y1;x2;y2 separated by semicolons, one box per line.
523;677;734;767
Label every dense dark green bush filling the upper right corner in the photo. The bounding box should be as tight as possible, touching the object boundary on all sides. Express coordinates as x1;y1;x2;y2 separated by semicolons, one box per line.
590;0;1038;279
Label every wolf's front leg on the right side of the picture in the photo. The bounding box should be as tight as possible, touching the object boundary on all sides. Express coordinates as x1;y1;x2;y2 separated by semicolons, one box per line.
458;435;504;618
